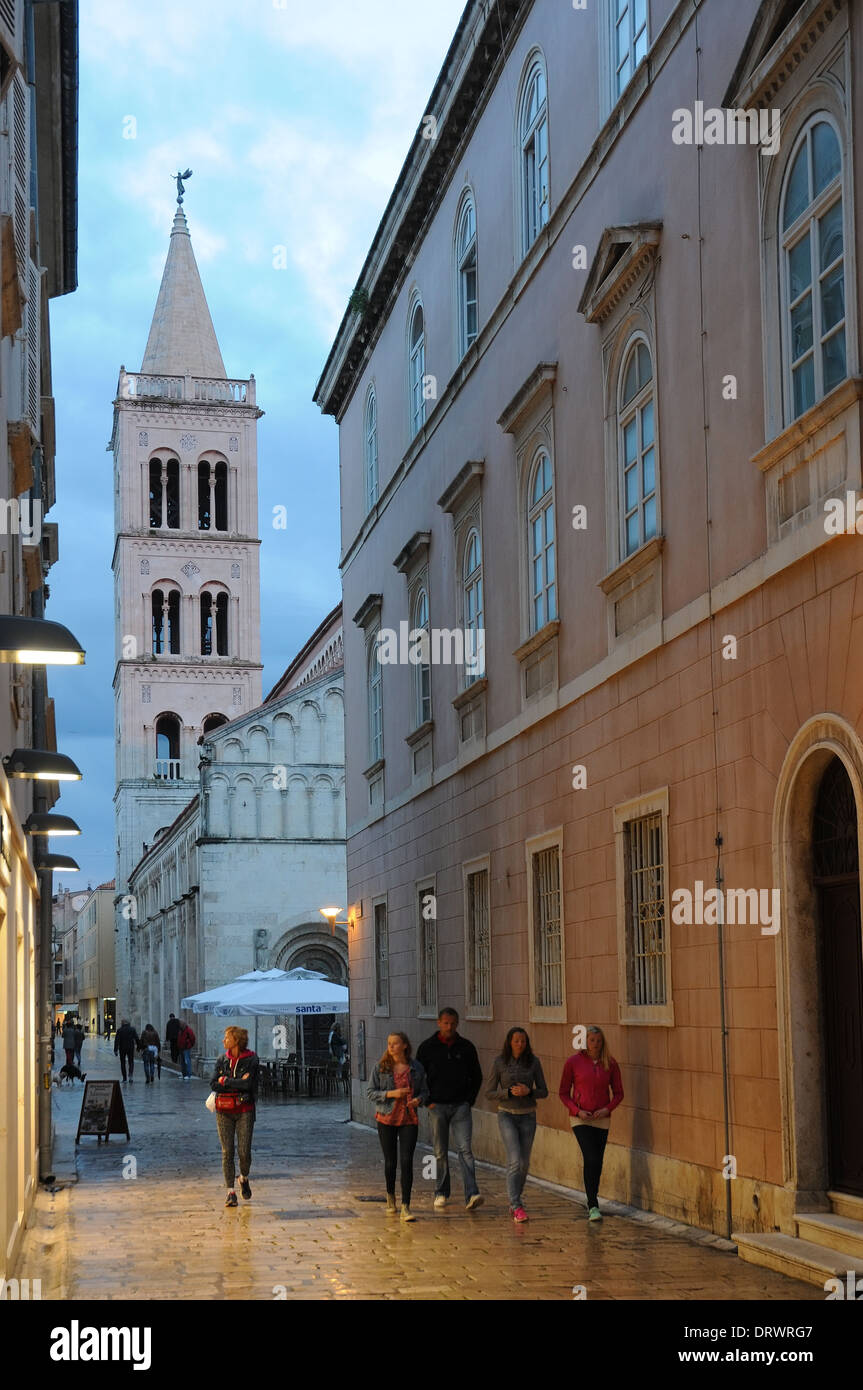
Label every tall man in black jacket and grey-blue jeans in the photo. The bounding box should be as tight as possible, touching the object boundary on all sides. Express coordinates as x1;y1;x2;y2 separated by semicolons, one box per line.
417;1009;482;1211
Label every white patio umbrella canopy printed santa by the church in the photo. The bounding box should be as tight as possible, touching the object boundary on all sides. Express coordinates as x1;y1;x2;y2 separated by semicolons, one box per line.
179;966;349;1054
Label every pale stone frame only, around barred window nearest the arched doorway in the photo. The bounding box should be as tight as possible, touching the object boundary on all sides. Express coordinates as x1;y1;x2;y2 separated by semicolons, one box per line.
613;787;674;1027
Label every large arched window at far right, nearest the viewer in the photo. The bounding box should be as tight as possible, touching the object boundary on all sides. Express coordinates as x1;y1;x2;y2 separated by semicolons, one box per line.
781;115;848;420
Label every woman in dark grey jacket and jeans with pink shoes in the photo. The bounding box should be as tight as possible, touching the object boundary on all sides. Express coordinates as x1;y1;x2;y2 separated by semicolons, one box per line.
485;1027;549;1225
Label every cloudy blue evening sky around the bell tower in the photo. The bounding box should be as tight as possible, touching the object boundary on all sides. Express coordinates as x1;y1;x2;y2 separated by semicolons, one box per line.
47;0;463;887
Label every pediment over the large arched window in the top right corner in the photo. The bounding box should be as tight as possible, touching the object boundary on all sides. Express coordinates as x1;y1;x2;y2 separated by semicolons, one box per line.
723;0;848;110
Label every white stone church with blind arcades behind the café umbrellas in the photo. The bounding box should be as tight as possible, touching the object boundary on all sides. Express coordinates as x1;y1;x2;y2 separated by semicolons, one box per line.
129;607;347;1070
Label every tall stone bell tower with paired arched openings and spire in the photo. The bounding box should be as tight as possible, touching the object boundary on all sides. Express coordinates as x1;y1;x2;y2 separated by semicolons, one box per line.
108;199;263;1013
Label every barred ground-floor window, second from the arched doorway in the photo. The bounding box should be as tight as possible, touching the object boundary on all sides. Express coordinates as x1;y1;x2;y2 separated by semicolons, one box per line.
527;831;566;1023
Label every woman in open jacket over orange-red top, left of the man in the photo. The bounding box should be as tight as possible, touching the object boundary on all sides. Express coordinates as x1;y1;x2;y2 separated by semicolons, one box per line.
368;1033;428;1220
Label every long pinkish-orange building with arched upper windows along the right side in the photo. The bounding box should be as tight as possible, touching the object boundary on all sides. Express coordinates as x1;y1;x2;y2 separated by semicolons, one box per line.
315;0;863;1282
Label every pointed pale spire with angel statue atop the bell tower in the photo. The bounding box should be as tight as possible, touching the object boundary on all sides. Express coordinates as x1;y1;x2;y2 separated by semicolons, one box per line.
140;195;225;378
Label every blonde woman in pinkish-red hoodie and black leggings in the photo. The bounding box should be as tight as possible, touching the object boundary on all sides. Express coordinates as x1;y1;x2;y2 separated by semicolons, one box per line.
559;1024;623;1220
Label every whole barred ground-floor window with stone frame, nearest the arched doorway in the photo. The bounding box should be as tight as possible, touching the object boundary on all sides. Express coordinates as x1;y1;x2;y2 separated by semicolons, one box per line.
614;790;674;1024
